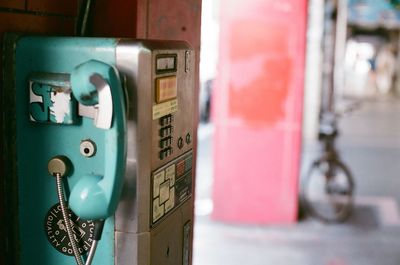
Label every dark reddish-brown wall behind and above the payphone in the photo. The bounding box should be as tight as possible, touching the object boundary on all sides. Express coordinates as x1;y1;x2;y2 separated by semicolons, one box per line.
0;0;201;264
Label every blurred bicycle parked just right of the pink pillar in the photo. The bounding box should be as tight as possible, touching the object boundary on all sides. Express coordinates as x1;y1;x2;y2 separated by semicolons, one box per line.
300;114;354;223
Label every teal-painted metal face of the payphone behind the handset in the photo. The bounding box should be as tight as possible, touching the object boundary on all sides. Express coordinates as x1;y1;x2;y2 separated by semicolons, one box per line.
16;37;121;265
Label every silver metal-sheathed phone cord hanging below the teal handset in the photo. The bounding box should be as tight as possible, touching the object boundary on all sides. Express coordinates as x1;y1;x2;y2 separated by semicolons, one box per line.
54;173;104;265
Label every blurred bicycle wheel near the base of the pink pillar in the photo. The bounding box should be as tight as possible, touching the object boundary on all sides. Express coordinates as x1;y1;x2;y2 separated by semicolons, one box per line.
300;160;354;222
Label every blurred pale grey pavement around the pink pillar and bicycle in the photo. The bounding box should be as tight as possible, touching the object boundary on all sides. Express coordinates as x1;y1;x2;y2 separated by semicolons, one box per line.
194;98;400;265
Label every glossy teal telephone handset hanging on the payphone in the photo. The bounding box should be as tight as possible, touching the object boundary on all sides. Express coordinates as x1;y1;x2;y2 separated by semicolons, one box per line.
68;60;127;220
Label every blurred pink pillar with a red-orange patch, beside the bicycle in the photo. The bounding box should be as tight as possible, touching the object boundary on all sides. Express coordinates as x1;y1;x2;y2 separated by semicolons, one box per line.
213;0;307;224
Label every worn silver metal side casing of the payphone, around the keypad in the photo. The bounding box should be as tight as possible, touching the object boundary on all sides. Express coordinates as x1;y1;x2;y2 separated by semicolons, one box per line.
115;39;196;265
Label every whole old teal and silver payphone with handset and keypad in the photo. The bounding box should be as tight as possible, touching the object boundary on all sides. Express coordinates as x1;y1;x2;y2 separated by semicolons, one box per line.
2;34;195;265
